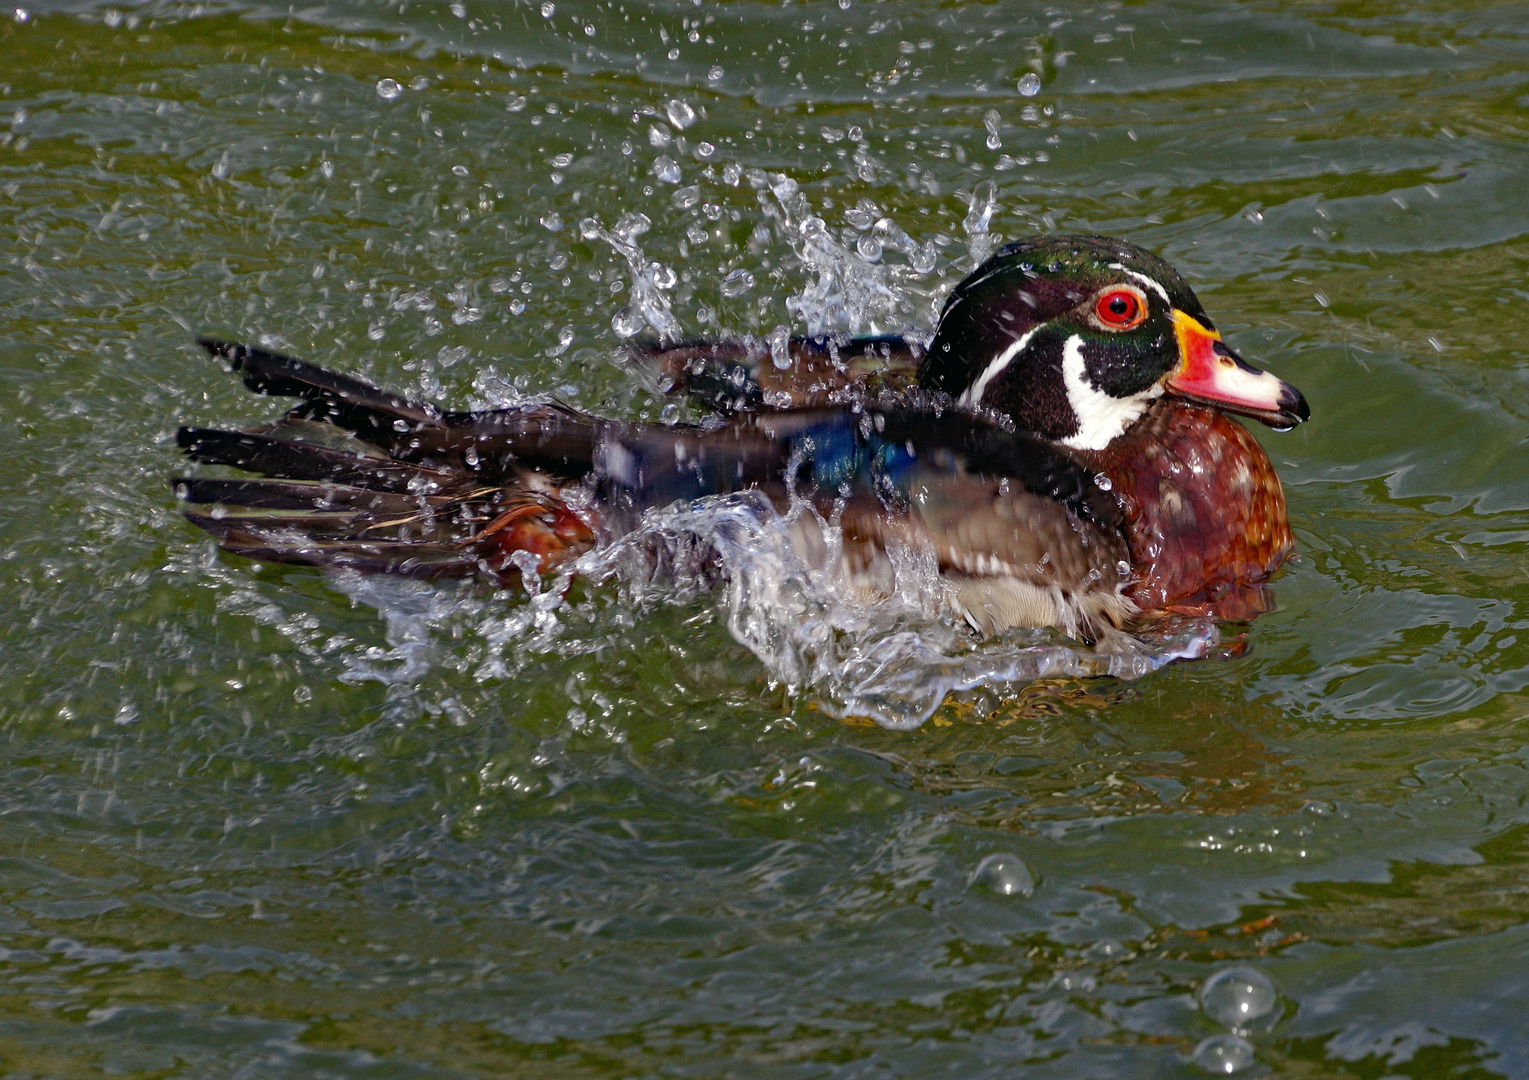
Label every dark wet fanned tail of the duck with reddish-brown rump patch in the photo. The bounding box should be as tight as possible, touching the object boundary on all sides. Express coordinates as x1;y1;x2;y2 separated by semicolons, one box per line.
174;338;602;577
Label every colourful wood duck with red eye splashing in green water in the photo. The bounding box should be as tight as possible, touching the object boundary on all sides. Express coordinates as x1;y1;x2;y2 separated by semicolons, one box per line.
176;236;1309;641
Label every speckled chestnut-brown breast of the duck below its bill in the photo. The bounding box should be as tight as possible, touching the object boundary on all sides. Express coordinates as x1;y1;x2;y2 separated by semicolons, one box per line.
1083;399;1295;621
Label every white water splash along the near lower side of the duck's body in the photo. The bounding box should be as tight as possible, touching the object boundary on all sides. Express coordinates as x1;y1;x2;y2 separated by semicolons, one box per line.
434;491;1219;730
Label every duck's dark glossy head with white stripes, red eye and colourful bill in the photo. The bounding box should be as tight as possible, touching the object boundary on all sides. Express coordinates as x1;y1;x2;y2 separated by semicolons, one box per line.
919;236;1310;450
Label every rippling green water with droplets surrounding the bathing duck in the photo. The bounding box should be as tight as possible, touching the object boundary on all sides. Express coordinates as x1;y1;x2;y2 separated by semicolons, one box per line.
0;0;1529;1077
